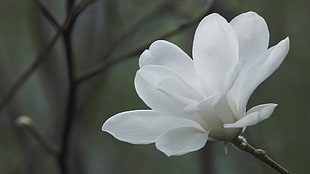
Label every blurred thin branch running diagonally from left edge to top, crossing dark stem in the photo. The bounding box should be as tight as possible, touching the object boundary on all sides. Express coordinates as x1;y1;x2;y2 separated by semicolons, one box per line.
0;0;95;111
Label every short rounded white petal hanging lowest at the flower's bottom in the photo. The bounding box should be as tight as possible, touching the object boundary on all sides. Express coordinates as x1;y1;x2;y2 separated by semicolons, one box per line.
156;127;208;156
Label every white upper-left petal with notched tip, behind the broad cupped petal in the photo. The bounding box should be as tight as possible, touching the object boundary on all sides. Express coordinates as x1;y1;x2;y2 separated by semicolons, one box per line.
139;40;202;91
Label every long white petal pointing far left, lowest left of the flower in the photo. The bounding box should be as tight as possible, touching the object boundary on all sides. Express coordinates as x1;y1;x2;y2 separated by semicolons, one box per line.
102;110;199;144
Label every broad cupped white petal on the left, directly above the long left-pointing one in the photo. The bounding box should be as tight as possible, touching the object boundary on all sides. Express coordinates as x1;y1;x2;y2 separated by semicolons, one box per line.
135;65;200;116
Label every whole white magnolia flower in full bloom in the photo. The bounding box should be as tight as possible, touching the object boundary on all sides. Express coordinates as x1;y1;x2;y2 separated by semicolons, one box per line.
102;12;289;156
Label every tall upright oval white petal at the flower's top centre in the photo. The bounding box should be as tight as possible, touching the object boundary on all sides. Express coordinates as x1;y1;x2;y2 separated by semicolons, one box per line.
193;14;239;96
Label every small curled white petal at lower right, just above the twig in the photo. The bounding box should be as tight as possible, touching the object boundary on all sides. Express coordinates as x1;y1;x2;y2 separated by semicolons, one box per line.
224;104;277;128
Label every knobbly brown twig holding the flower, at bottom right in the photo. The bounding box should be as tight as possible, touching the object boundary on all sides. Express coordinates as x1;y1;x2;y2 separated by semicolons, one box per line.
231;136;291;174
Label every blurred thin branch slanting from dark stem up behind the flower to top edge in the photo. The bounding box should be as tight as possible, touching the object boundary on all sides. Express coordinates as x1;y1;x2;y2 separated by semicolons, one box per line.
76;1;213;84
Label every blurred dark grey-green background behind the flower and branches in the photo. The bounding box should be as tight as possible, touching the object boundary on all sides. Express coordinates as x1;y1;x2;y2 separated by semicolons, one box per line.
0;0;310;174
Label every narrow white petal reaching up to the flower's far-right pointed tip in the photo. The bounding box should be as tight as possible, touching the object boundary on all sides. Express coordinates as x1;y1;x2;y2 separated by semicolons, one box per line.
228;38;289;116
